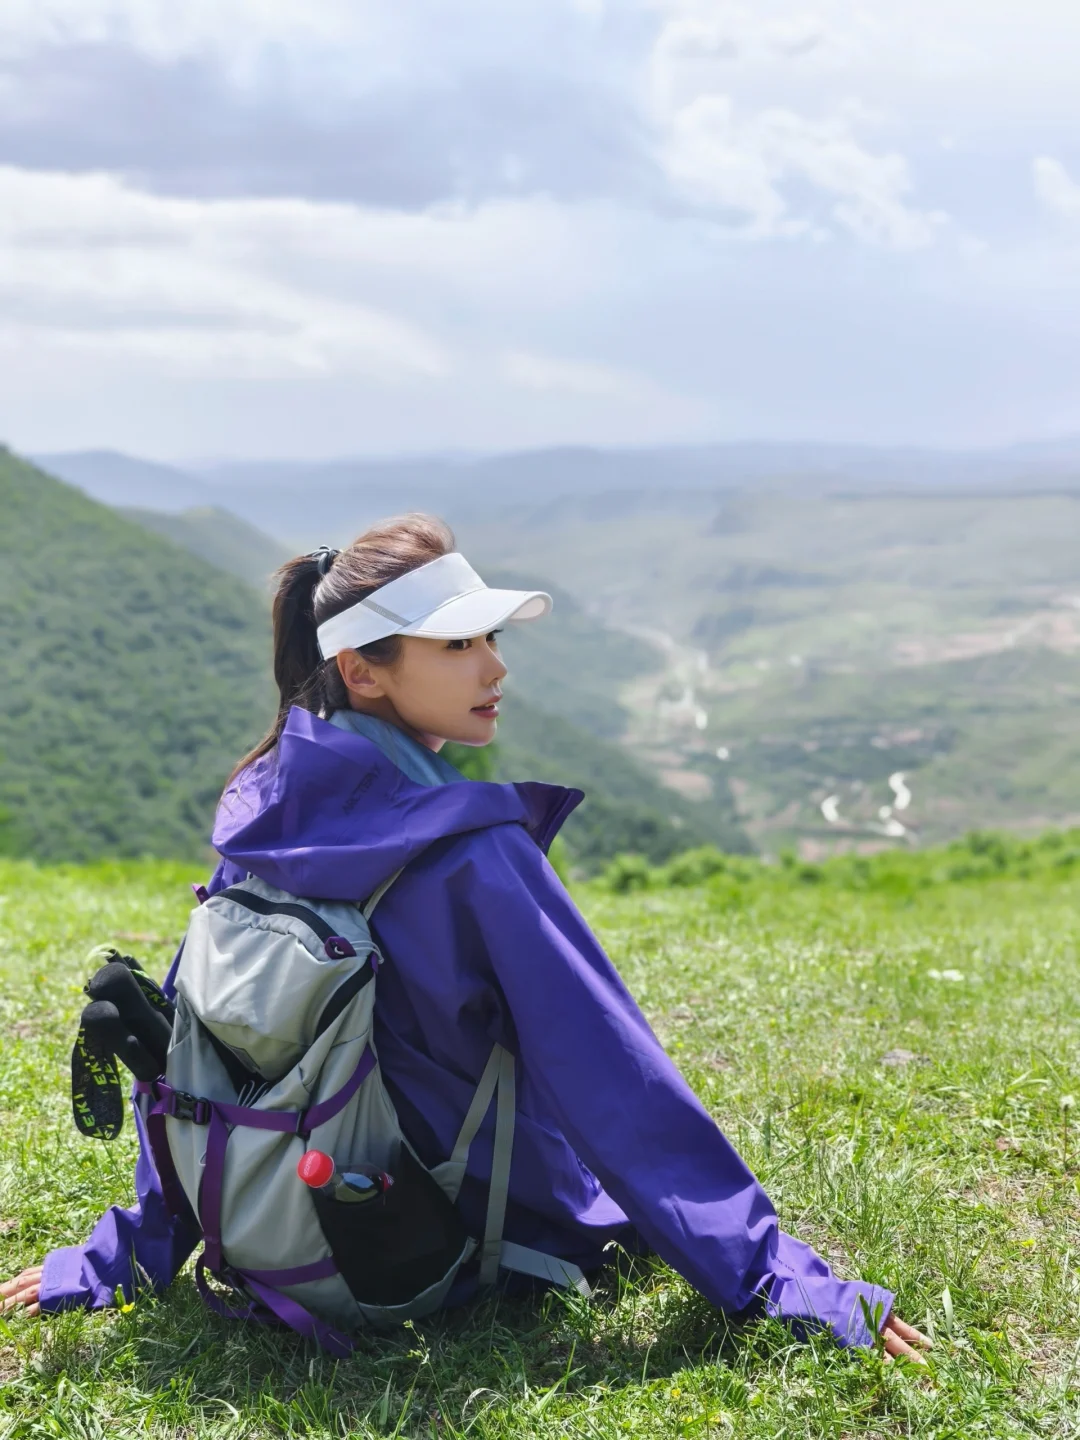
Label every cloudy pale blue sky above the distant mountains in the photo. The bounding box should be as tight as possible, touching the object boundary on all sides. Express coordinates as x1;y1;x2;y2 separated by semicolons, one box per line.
0;0;1080;458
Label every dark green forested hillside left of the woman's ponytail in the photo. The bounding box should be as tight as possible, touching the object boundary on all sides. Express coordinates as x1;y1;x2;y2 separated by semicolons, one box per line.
0;452;272;858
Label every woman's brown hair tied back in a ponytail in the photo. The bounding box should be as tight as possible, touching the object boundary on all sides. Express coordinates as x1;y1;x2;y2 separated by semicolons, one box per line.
233;514;454;788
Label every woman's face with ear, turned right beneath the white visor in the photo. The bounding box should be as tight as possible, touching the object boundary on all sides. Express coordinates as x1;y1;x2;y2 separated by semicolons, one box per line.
337;631;507;750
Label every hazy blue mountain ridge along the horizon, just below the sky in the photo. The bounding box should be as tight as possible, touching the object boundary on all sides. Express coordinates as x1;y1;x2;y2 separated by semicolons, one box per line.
35;438;1080;547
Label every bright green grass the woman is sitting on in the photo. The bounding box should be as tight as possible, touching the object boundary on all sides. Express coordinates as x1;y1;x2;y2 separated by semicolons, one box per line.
0;841;1080;1440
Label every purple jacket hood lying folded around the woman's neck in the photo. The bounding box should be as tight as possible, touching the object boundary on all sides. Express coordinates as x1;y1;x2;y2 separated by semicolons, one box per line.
213;708;585;900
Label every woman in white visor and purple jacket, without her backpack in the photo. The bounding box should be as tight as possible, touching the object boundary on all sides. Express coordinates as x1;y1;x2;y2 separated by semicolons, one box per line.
0;516;924;1358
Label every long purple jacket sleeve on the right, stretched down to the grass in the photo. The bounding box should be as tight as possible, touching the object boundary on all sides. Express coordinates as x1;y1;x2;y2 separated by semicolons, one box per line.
452;827;893;1345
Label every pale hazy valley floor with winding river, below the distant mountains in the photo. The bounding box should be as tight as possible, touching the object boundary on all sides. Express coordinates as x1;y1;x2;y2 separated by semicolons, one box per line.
462;475;1080;857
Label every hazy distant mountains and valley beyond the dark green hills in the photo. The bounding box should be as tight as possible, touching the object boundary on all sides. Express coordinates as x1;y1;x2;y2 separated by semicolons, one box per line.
19;439;1080;855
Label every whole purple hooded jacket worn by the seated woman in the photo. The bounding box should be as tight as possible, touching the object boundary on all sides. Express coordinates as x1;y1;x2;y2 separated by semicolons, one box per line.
42;710;893;1345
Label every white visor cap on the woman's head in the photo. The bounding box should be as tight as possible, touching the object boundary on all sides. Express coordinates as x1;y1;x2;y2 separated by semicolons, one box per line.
318;550;552;660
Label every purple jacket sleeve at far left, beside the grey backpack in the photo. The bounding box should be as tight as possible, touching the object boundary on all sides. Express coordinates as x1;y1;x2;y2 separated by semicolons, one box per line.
40;1110;200;1312
